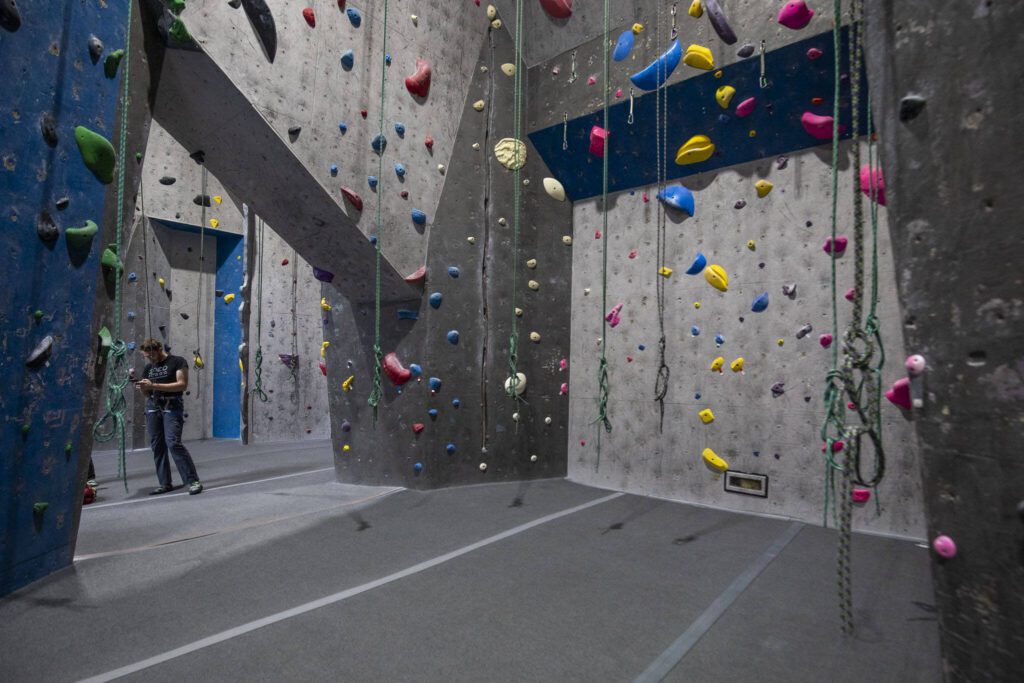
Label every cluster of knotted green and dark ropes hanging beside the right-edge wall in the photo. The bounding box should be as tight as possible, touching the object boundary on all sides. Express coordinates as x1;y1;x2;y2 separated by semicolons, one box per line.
821;0;885;634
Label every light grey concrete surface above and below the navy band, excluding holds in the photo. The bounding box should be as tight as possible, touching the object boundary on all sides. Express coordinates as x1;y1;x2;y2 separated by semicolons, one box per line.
526;2;925;538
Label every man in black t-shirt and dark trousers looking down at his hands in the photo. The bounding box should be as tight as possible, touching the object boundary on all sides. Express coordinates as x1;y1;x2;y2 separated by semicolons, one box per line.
132;339;203;496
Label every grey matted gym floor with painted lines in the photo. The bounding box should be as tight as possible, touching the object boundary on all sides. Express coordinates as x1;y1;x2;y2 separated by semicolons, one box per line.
0;441;941;683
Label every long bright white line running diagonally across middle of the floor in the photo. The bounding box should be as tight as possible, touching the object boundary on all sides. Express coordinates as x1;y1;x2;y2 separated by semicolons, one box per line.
80;494;625;683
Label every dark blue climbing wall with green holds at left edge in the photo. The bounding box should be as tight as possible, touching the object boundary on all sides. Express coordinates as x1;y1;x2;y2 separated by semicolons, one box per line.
0;0;128;595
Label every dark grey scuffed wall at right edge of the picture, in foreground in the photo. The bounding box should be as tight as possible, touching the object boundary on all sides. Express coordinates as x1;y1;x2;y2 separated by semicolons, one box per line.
867;0;1024;681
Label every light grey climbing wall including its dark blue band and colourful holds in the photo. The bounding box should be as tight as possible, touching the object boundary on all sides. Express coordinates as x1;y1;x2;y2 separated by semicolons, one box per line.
527;2;925;538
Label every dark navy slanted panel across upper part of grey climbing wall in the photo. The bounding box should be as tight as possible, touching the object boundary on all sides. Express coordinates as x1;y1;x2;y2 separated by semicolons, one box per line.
529;28;867;201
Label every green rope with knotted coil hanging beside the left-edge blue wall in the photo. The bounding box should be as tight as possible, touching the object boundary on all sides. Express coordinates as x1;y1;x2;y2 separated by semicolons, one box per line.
92;2;135;493
